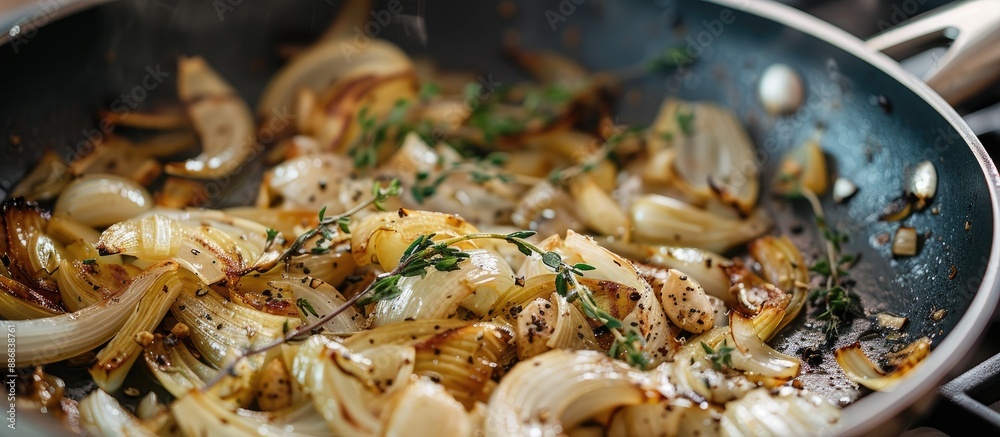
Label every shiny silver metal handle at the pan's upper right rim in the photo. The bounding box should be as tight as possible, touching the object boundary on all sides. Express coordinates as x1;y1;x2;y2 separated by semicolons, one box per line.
866;0;1000;106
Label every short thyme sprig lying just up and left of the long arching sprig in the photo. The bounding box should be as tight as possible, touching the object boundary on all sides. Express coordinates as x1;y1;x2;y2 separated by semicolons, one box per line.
257;179;402;271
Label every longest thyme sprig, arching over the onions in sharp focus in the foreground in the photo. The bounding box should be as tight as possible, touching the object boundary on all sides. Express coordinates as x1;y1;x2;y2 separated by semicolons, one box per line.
209;228;648;390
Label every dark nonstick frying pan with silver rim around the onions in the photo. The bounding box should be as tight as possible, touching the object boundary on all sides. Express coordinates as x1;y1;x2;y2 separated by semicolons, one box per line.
0;0;1000;435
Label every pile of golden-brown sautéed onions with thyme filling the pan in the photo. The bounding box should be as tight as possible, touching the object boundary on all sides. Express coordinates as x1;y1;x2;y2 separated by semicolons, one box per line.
0;14;937;436
